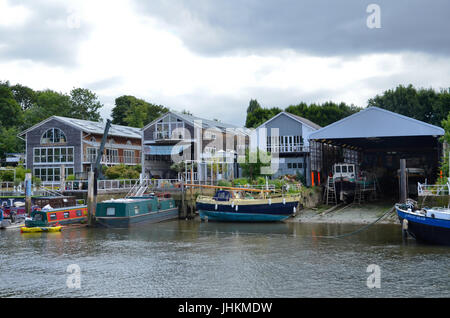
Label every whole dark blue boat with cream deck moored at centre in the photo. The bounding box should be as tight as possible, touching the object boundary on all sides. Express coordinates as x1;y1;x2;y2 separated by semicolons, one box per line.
196;190;299;222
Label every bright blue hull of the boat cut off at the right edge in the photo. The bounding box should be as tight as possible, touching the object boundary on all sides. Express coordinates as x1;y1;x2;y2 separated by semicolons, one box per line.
396;207;450;245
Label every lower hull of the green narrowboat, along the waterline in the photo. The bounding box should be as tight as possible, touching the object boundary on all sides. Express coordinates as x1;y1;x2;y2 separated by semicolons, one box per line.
96;208;179;228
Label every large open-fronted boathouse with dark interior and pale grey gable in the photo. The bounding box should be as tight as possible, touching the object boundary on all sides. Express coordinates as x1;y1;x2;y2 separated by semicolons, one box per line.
309;107;444;197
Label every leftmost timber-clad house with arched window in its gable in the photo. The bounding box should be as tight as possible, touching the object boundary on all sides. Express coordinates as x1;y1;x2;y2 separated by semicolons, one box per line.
18;116;141;184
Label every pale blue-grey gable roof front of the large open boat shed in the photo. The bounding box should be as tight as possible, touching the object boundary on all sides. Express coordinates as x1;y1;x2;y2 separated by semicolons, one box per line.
309;107;444;139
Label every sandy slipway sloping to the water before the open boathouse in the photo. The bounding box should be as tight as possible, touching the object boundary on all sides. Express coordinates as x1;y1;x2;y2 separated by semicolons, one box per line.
288;203;399;224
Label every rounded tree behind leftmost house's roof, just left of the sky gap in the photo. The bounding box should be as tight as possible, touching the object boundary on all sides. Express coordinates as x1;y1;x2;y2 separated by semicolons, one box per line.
69;88;103;121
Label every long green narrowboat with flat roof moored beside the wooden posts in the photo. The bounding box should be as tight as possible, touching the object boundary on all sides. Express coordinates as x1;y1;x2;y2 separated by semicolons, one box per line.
95;195;178;228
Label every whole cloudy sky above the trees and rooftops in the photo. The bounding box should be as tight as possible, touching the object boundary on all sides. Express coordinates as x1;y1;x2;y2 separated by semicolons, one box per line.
0;0;450;125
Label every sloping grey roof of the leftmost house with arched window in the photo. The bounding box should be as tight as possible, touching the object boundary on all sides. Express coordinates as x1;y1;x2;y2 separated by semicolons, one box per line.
53;116;141;139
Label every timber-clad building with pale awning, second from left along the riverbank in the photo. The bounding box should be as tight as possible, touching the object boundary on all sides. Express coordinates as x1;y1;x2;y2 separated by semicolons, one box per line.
142;111;249;181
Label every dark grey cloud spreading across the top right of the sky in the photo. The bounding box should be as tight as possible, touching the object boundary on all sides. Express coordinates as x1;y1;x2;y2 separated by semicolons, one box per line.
135;0;450;56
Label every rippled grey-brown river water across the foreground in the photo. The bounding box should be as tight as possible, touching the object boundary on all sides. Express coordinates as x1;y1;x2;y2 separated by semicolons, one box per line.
0;220;450;298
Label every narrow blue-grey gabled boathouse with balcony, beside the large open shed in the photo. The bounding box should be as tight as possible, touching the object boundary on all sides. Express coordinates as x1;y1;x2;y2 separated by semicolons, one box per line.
257;111;321;185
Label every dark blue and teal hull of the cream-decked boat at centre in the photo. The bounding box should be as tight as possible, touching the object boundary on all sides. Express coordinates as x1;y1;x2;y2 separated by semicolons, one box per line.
197;201;298;222
